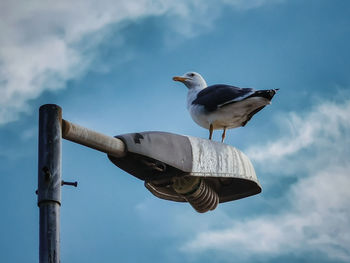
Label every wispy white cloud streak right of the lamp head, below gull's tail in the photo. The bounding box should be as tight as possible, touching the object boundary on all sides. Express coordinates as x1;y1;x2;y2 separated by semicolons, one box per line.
247;101;350;162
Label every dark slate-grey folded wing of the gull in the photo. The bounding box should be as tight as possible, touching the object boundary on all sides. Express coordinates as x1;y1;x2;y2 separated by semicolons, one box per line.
192;84;255;111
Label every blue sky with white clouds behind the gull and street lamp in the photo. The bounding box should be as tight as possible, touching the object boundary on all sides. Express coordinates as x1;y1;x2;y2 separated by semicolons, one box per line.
0;0;350;263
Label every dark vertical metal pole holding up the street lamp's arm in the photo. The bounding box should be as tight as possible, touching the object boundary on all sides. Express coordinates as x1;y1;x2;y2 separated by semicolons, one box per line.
38;104;62;263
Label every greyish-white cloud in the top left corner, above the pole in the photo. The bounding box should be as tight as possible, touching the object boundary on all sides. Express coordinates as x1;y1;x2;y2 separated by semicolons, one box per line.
0;0;280;124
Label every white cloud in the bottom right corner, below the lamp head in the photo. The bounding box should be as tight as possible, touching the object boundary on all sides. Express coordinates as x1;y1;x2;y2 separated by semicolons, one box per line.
183;165;350;261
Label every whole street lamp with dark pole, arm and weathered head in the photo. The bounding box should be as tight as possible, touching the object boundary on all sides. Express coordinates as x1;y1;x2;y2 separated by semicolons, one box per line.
37;104;261;263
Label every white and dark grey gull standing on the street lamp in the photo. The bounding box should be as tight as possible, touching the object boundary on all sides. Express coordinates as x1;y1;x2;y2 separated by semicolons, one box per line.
173;72;279;143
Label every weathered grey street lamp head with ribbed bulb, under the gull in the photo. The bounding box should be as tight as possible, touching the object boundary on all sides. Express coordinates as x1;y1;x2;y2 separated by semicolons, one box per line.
108;132;261;212
